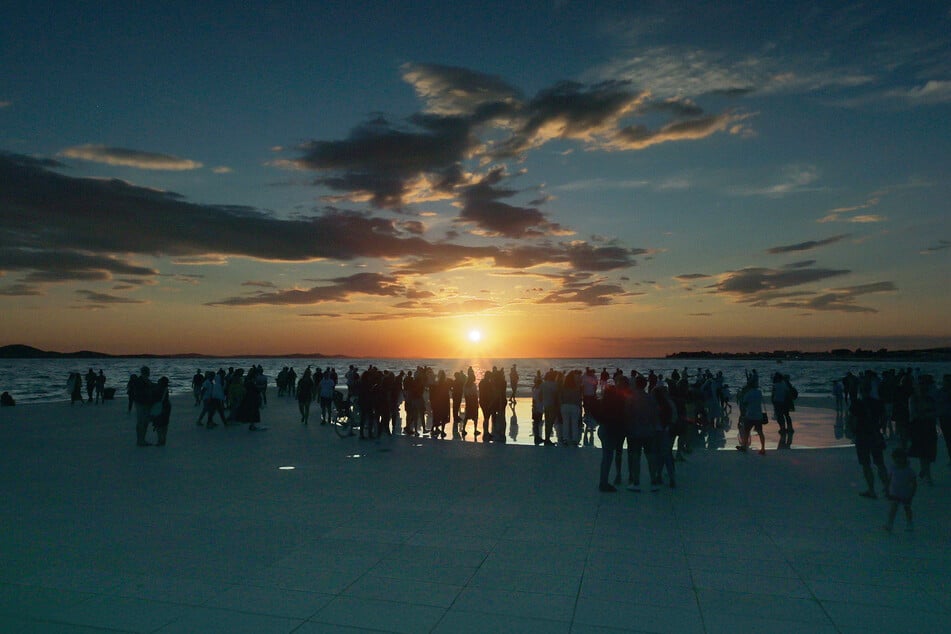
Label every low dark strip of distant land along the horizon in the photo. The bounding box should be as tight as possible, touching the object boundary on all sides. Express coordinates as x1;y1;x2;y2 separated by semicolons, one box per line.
0;344;951;363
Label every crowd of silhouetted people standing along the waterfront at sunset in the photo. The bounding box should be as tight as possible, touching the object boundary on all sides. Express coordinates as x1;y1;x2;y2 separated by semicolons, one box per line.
113;365;951;526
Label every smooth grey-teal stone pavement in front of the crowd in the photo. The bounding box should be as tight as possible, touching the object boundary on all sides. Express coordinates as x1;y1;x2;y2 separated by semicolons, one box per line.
0;396;951;634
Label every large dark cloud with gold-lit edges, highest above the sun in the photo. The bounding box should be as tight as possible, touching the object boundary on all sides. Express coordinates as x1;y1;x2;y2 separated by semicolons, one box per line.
286;64;750;210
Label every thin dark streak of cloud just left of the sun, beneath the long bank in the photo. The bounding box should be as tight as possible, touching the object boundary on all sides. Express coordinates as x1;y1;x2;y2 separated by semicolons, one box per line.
209;273;405;306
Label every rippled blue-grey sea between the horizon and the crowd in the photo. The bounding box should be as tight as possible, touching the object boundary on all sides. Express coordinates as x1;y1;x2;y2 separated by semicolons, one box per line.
0;357;951;403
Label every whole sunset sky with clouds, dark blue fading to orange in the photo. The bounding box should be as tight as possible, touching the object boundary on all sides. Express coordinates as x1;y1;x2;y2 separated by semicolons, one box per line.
0;0;951;358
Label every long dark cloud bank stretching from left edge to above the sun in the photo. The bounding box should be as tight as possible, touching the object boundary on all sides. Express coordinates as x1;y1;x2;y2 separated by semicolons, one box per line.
0;153;649;296
